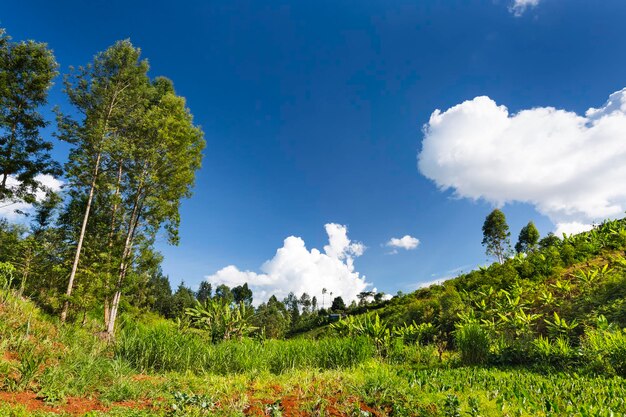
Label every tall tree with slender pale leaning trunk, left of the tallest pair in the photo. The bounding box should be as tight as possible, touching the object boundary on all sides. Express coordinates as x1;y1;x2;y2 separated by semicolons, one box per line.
58;40;148;321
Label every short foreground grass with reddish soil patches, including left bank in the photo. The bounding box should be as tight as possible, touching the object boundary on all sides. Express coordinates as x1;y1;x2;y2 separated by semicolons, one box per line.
0;292;626;417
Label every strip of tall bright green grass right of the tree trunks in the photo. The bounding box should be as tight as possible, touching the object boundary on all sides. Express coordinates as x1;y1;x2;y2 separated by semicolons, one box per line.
115;323;376;375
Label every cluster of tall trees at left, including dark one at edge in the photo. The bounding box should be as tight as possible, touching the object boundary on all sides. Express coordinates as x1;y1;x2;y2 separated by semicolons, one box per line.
0;29;205;334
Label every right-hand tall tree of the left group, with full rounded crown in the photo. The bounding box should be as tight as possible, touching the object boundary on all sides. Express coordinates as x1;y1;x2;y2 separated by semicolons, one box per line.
106;78;205;335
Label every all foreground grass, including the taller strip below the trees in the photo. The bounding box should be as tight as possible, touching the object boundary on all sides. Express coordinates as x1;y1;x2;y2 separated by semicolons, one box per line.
0;290;626;417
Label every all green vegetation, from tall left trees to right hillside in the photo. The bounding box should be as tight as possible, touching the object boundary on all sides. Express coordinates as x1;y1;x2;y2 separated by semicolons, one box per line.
0;24;626;417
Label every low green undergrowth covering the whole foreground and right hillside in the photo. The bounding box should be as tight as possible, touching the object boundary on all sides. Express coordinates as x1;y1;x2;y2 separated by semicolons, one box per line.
0;221;626;417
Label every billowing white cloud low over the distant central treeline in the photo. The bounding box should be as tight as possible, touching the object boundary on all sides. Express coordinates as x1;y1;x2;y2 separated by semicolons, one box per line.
206;223;371;306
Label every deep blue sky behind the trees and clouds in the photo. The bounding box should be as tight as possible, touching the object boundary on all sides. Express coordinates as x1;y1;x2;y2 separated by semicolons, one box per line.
0;0;626;300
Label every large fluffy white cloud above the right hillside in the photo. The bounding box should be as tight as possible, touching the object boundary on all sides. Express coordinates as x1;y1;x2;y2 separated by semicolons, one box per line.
418;88;626;232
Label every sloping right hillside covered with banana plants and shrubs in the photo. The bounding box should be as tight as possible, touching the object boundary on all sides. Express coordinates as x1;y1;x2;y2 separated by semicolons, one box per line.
309;220;626;375
